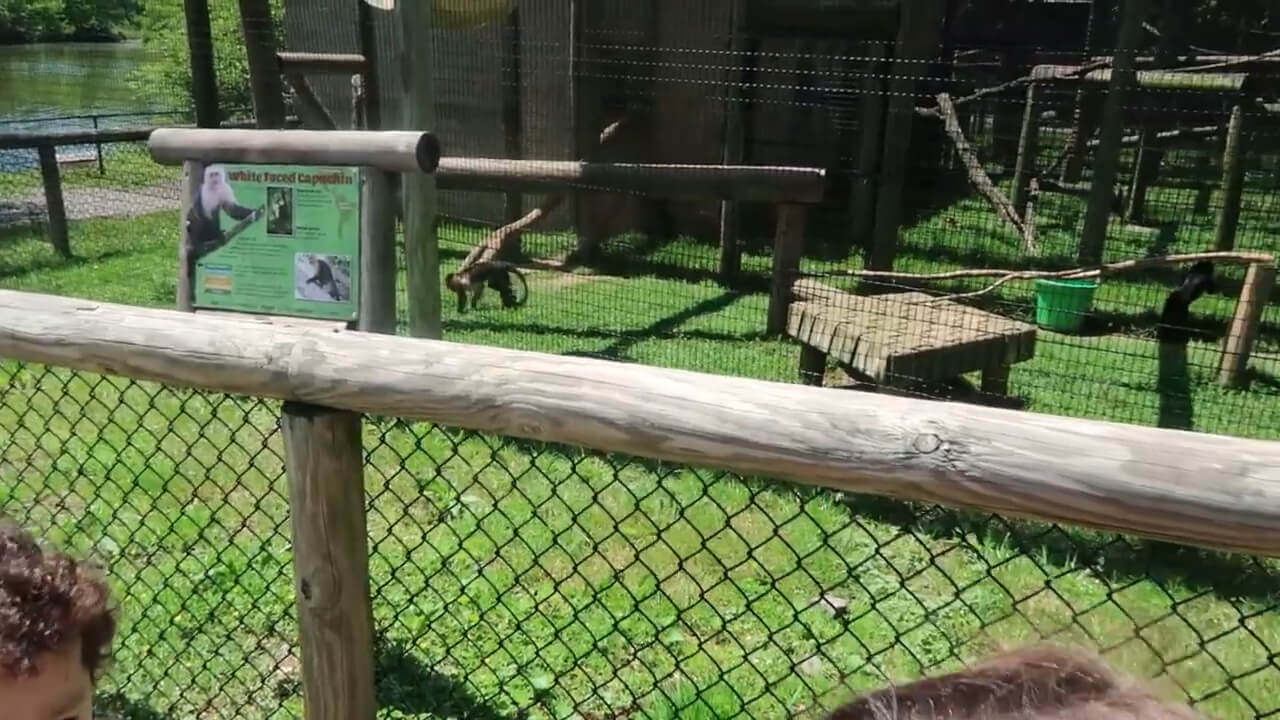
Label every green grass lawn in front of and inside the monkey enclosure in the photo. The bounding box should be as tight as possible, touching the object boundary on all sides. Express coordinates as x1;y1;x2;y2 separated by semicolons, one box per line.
0;166;1280;719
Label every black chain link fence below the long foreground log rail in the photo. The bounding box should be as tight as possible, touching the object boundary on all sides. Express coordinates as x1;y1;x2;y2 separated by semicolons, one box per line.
0;361;1280;720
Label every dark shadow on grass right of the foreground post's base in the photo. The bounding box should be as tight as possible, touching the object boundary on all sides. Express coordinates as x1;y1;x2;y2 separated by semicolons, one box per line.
374;634;506;720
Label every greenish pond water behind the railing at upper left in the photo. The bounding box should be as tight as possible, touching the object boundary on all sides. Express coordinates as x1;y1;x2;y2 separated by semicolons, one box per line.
0;41;179;172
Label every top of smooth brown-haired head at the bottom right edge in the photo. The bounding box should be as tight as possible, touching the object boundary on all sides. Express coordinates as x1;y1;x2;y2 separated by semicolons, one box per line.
827;646;1206;720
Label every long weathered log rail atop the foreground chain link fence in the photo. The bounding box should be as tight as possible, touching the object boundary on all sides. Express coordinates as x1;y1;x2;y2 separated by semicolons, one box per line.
0;291;1280;556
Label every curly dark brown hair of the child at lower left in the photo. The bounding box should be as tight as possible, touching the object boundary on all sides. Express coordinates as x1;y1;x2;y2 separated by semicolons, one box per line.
0;518;115;680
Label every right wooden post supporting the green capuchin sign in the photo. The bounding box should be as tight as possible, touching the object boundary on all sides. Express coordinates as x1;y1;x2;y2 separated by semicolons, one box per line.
356;168;397;334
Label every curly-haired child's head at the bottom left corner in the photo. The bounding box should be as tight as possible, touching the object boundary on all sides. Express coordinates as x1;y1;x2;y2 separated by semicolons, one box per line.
0;519;115;720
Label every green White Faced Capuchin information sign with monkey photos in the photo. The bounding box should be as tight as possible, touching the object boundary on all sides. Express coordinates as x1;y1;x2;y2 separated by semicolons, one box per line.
187;164;360;320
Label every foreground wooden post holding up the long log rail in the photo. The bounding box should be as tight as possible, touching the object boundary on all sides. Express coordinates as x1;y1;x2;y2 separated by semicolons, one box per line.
280;402;376;720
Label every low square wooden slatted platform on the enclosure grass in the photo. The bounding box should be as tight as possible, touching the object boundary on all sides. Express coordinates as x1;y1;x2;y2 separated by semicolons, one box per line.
787;287;1036;395
